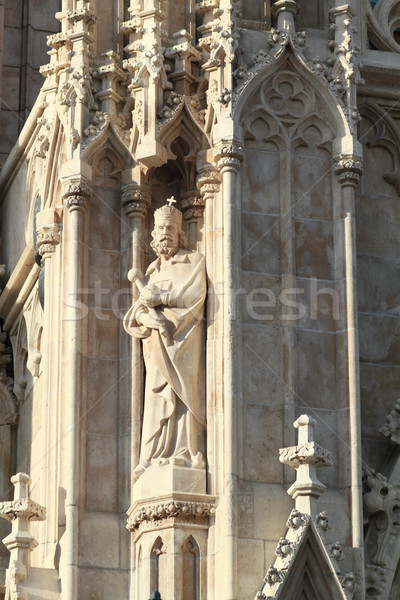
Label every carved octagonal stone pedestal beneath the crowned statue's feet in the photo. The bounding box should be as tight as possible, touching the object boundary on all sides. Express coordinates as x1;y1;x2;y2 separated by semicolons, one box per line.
127;494;215;600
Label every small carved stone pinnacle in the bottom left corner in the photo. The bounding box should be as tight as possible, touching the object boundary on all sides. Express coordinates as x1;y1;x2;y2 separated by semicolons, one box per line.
0;473;46;599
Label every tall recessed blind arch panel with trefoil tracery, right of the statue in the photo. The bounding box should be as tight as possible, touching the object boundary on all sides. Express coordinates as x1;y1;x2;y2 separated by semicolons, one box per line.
235;53;348;486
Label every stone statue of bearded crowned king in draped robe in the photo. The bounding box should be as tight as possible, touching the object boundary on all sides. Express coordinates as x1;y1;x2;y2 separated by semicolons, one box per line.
124;198;206;477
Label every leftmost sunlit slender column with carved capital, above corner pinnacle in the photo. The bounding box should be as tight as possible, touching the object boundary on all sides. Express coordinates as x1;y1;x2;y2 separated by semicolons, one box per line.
36;208;60;564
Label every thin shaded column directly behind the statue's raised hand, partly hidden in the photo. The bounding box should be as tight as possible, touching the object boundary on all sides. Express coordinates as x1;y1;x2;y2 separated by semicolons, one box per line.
122;182;151;492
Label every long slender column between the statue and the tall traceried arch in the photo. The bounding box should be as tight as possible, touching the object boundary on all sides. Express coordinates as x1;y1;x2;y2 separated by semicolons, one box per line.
214;142;243;600
